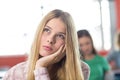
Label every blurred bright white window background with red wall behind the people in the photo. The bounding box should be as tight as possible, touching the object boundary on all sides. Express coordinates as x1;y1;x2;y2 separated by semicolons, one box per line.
0;0;120;79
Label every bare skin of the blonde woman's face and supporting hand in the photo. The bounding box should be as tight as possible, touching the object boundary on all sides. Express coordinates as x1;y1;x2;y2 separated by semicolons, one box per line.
36;18;66;68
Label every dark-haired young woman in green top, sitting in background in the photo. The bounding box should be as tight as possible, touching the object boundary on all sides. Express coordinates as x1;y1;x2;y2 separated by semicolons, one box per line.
77;30;109;80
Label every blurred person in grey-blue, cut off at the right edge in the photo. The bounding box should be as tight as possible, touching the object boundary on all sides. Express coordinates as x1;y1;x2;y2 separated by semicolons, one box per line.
107;31;120;80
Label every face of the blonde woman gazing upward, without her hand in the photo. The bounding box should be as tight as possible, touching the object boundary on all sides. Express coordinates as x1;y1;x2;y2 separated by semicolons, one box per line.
39;18;66;56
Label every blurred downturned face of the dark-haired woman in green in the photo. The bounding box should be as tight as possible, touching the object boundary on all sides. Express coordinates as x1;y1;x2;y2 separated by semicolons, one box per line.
78;36;93;55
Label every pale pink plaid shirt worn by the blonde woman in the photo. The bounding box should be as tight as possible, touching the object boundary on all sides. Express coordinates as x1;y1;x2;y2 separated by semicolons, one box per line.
3;62;90;80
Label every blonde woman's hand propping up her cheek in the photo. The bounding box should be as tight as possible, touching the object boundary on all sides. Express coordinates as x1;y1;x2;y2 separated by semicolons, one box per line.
35;45;65;68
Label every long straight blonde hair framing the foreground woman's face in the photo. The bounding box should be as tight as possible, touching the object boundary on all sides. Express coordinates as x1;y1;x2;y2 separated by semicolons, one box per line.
27;9;84;80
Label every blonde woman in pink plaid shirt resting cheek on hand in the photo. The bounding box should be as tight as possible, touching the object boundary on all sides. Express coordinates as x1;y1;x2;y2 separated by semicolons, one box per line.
3;9;89;80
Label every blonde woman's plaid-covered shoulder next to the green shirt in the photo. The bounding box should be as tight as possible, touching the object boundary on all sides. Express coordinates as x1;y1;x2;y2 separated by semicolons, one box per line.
81;61;90;80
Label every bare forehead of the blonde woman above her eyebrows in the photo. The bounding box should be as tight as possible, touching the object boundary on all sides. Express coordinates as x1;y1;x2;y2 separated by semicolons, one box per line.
46;18;66;32
